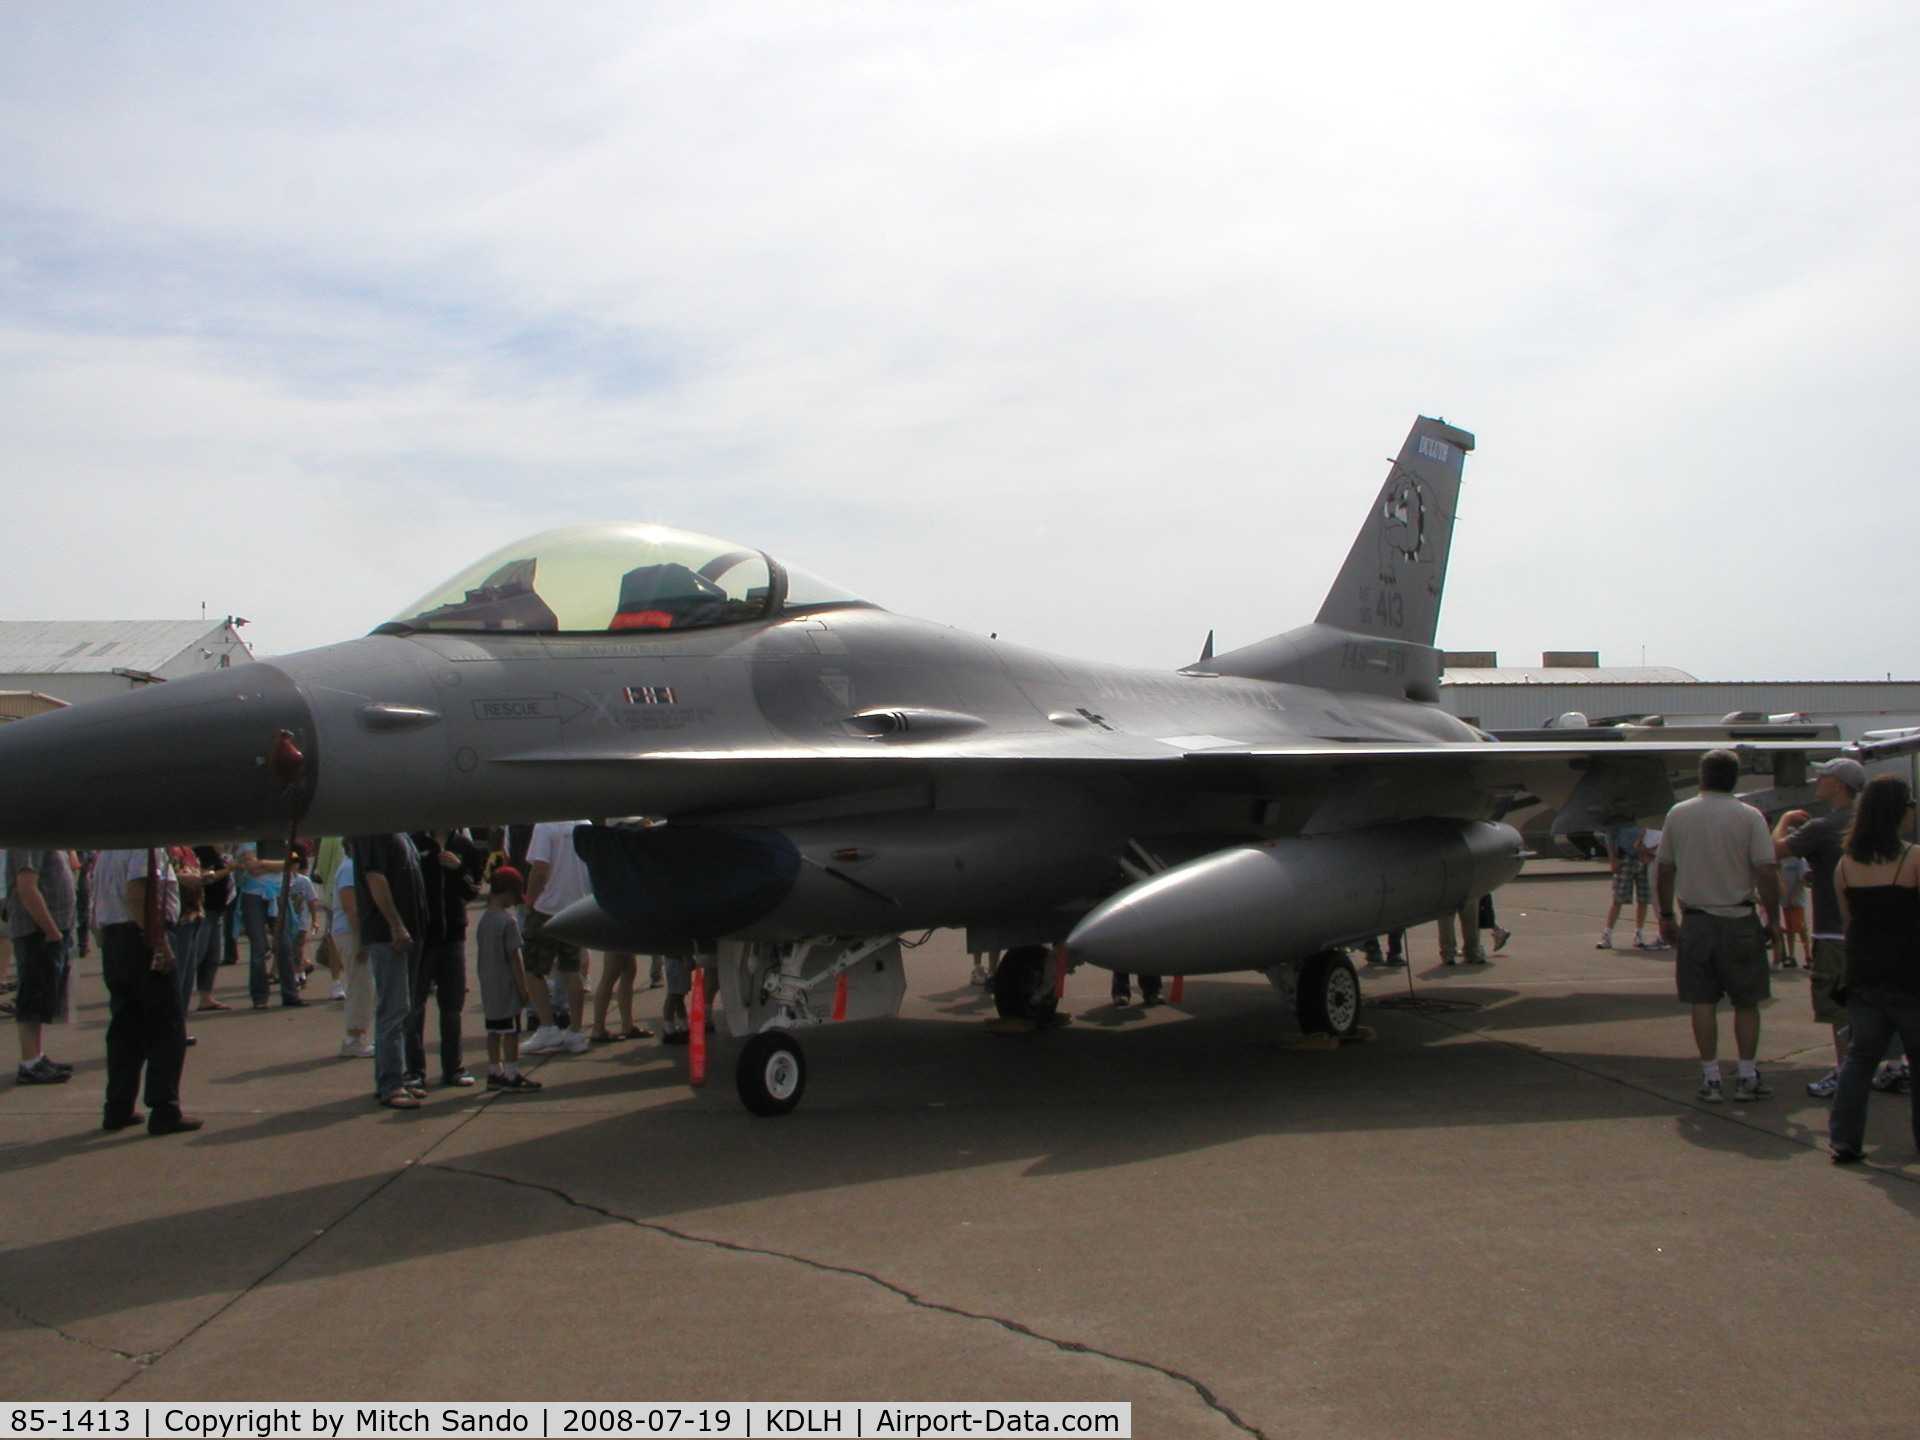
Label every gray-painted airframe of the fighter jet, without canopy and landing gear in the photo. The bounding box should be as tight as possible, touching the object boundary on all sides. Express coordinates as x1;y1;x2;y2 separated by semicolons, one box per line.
0;419;1889;973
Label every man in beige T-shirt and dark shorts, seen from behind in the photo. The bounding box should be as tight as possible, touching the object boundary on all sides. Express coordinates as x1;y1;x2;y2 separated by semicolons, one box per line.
1655;751;1780;1104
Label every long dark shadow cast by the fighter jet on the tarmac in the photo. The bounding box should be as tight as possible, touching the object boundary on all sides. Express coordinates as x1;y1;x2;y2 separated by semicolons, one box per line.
15;985;1920;1327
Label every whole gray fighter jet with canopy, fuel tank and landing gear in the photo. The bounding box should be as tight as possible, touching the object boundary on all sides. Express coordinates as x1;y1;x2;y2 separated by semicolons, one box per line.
0;417;1896;1114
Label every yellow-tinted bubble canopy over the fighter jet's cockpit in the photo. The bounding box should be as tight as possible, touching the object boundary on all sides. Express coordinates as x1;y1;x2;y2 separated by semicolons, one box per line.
382;524;868;634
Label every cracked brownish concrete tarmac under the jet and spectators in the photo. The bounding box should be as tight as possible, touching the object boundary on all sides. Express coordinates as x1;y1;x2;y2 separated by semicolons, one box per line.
0;862;1920;1440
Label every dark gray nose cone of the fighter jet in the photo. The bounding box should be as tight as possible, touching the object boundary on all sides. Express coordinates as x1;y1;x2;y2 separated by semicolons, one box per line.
0;664;319;849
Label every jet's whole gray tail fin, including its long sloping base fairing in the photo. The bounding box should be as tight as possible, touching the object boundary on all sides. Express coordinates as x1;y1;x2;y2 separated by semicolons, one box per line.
1188;415;1473;703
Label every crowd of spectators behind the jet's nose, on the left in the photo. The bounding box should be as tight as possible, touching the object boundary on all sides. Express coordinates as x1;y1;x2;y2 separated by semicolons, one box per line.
0;822;718;1135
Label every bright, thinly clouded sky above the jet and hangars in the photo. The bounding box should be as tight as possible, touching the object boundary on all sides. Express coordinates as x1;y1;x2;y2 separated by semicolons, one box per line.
0;0;1920;680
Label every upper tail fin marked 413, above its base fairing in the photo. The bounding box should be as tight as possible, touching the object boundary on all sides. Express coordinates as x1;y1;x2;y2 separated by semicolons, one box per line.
1315;415;1473;645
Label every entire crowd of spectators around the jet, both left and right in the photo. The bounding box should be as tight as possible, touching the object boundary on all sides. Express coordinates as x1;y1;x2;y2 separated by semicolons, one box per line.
15;768;1920;1164
